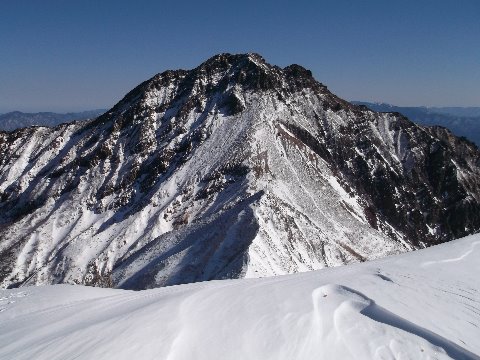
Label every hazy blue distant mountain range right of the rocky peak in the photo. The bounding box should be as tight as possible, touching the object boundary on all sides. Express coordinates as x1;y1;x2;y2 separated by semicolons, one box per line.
352;101;480;146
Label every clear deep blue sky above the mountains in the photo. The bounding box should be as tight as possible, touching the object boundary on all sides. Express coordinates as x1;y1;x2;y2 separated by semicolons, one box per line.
0;0;480;112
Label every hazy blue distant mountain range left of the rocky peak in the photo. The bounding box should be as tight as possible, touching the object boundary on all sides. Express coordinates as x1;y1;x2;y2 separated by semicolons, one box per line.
0;109;106;131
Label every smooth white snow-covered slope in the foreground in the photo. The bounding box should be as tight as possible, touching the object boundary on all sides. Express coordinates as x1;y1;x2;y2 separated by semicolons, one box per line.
0;235;480;360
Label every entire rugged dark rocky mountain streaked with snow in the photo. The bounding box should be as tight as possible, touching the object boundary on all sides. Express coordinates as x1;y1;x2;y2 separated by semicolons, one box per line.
0;54;480;289
